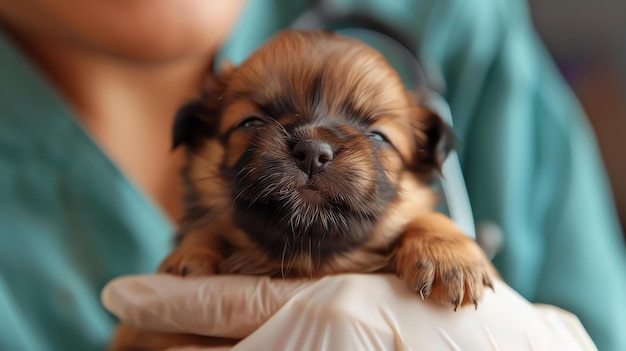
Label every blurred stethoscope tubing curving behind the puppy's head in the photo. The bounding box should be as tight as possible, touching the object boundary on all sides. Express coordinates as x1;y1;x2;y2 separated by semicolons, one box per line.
291;0;476;239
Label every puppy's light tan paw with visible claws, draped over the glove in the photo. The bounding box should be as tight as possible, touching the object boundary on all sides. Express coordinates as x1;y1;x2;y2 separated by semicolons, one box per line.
395;214;497;311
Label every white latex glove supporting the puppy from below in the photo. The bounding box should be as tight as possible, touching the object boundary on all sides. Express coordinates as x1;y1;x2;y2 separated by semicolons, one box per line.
102;274;597;351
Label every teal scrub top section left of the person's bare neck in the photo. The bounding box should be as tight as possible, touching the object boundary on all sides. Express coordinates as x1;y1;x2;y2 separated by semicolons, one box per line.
0;28;172;351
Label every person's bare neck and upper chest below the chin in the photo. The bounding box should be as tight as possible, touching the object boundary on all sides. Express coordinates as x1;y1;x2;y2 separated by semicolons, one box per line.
18;35;210;220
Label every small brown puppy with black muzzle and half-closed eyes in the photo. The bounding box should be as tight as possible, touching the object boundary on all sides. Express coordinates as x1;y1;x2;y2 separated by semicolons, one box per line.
111;32;496;351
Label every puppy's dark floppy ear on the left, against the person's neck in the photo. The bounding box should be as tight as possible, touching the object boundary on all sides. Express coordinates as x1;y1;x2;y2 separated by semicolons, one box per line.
172;67;232;151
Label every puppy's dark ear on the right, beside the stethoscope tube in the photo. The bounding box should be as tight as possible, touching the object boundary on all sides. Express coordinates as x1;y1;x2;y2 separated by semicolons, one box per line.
414;96;457;174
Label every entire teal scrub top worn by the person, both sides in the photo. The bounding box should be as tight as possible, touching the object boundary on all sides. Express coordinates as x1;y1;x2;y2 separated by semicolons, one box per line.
0;0;626;351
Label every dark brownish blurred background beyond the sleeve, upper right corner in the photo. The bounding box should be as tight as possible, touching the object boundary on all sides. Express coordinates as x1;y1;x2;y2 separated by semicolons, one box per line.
528;0;626;238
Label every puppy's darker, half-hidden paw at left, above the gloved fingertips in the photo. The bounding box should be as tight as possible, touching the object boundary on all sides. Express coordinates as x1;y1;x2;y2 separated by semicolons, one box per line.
158;247;221;277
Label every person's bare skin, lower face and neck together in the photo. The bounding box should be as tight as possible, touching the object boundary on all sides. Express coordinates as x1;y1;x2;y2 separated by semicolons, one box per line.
0;0;245;219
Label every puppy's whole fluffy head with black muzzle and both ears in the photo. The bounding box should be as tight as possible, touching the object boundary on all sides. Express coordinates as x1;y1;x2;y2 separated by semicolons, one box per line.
175;32;449;275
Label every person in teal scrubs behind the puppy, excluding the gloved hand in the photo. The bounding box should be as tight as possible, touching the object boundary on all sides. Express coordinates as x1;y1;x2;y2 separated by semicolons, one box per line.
0;0;626;350
